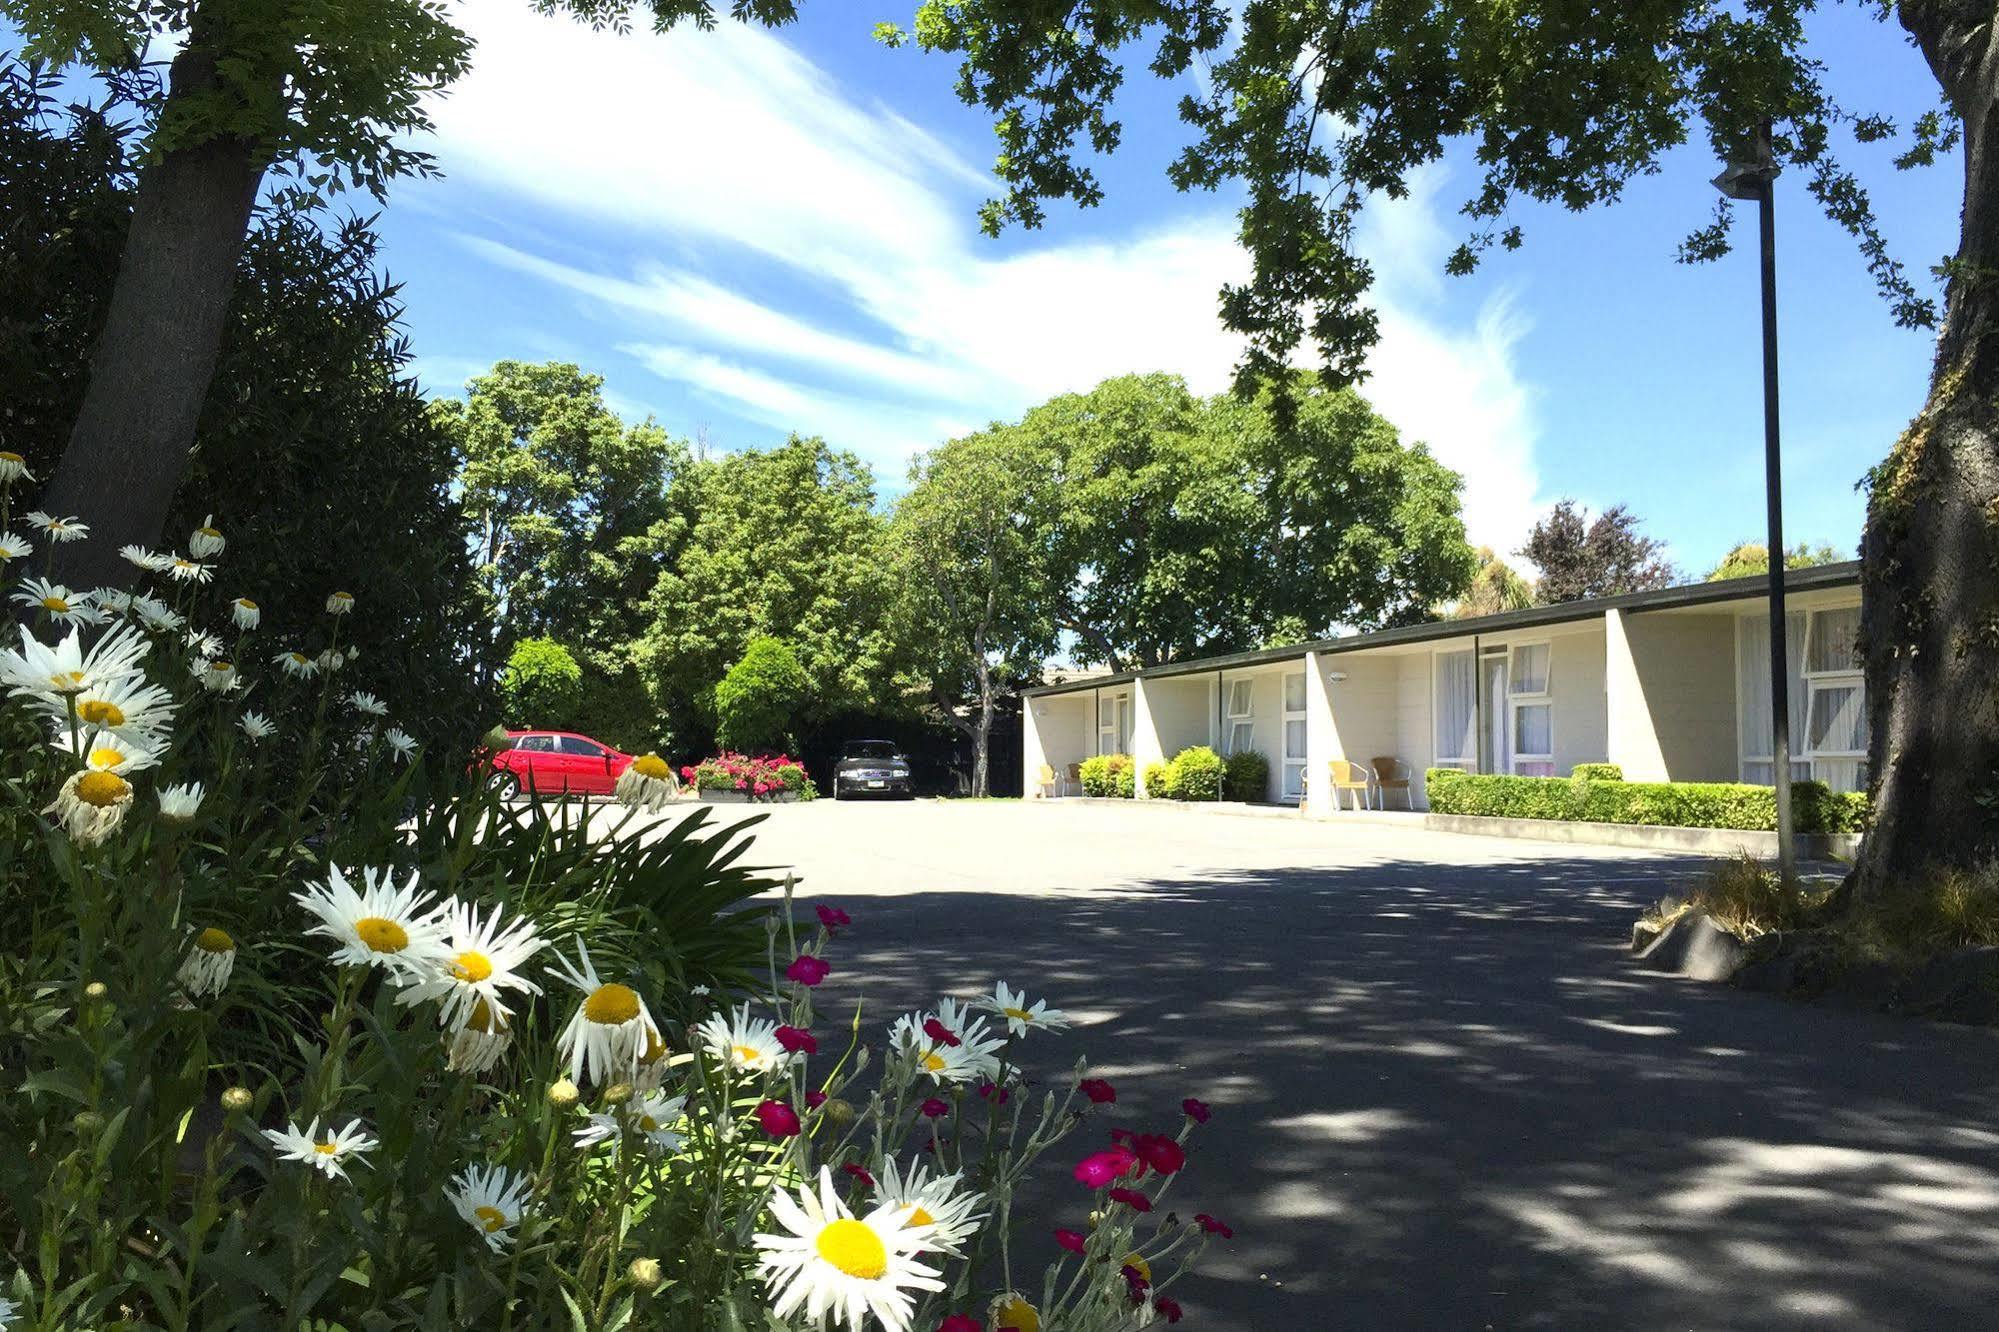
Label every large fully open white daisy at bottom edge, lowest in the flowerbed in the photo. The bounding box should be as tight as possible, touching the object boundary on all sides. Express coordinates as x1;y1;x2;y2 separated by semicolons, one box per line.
754;1166;944;1332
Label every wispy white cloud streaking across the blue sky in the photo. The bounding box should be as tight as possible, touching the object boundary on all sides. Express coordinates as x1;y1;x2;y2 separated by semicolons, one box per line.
436;6;1539;548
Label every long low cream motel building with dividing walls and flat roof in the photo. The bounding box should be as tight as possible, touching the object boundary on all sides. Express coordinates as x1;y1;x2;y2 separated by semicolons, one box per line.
1021;562;1867;814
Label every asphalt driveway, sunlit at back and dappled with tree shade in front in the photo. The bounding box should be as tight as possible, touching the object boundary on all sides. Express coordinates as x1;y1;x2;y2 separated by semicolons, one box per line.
683;802;1999;1328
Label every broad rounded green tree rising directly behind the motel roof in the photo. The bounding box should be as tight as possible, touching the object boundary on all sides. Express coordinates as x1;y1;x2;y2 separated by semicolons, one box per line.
1015;374;1475;666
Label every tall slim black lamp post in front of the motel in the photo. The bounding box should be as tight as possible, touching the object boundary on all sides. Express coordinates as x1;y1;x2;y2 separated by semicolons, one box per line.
1715;120;1797;878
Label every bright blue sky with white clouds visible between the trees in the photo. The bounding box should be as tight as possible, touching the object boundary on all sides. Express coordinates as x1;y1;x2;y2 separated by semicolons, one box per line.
120;0;1961;572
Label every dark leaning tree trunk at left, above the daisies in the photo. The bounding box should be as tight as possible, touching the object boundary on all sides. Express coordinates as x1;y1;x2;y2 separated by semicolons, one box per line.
42;38;268;586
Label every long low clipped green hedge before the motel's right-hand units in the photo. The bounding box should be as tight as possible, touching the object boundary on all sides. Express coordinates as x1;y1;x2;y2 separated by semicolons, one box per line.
1423;764;1867;832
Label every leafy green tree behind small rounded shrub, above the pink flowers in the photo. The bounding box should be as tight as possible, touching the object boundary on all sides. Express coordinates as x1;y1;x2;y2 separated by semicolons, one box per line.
634;436;902;742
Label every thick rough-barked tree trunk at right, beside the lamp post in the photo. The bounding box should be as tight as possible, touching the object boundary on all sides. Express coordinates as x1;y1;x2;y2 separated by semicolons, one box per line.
1851;0;1999;900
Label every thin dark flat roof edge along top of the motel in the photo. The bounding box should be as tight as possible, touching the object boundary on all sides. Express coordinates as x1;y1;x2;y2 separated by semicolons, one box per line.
1021;560;1861;698
